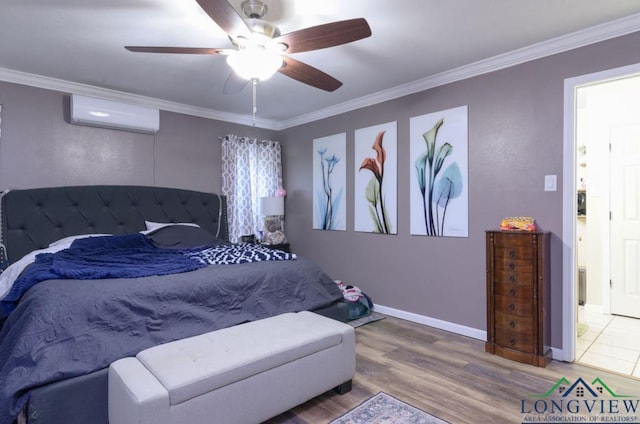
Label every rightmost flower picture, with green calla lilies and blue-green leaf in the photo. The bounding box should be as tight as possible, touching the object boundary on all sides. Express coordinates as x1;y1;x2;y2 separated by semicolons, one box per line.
410;106;469;237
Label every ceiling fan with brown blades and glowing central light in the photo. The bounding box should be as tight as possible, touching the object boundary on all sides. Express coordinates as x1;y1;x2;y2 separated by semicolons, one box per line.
125;0;371;94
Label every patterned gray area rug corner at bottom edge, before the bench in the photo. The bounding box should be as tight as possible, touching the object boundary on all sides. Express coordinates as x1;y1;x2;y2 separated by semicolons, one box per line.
331;392;448;424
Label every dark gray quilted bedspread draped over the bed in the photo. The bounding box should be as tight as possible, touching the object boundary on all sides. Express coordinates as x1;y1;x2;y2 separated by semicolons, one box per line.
0;258;342;424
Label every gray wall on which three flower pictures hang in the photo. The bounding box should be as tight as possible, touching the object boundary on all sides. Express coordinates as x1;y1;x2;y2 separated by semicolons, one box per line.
279;33;640;347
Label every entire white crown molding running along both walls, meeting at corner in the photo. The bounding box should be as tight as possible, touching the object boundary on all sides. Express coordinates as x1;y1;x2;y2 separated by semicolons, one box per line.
0;14;640;131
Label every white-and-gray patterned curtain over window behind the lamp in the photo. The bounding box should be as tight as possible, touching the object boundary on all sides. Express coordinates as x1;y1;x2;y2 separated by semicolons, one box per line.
220;134;282;242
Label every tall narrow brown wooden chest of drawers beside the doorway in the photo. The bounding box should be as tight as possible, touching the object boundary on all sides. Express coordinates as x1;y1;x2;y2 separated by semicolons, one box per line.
485;231;551;367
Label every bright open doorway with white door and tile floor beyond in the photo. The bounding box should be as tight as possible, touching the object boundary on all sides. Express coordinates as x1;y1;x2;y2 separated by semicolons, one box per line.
563;67;640;377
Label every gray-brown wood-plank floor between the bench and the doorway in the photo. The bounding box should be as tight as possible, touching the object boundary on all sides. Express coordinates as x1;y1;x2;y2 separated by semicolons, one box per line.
266;317;640;424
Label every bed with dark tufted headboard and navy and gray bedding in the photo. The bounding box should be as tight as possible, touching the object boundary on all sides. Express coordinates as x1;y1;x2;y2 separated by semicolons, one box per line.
0;186;345;424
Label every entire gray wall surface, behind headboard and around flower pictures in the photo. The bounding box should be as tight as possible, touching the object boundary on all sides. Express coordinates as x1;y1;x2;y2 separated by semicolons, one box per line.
0;33;640;347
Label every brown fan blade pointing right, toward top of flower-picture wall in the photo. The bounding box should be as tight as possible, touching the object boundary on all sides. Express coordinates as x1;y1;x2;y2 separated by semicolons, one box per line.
275;18;371;54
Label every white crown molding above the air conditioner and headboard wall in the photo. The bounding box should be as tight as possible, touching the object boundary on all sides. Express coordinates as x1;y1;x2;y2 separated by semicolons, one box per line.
0;68;278;130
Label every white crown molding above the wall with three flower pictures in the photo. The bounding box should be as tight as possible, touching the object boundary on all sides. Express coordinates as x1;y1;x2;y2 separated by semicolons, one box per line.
277;14;640;130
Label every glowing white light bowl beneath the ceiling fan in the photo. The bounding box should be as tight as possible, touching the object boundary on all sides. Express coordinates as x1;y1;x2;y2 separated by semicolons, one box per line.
227;46;283;81
